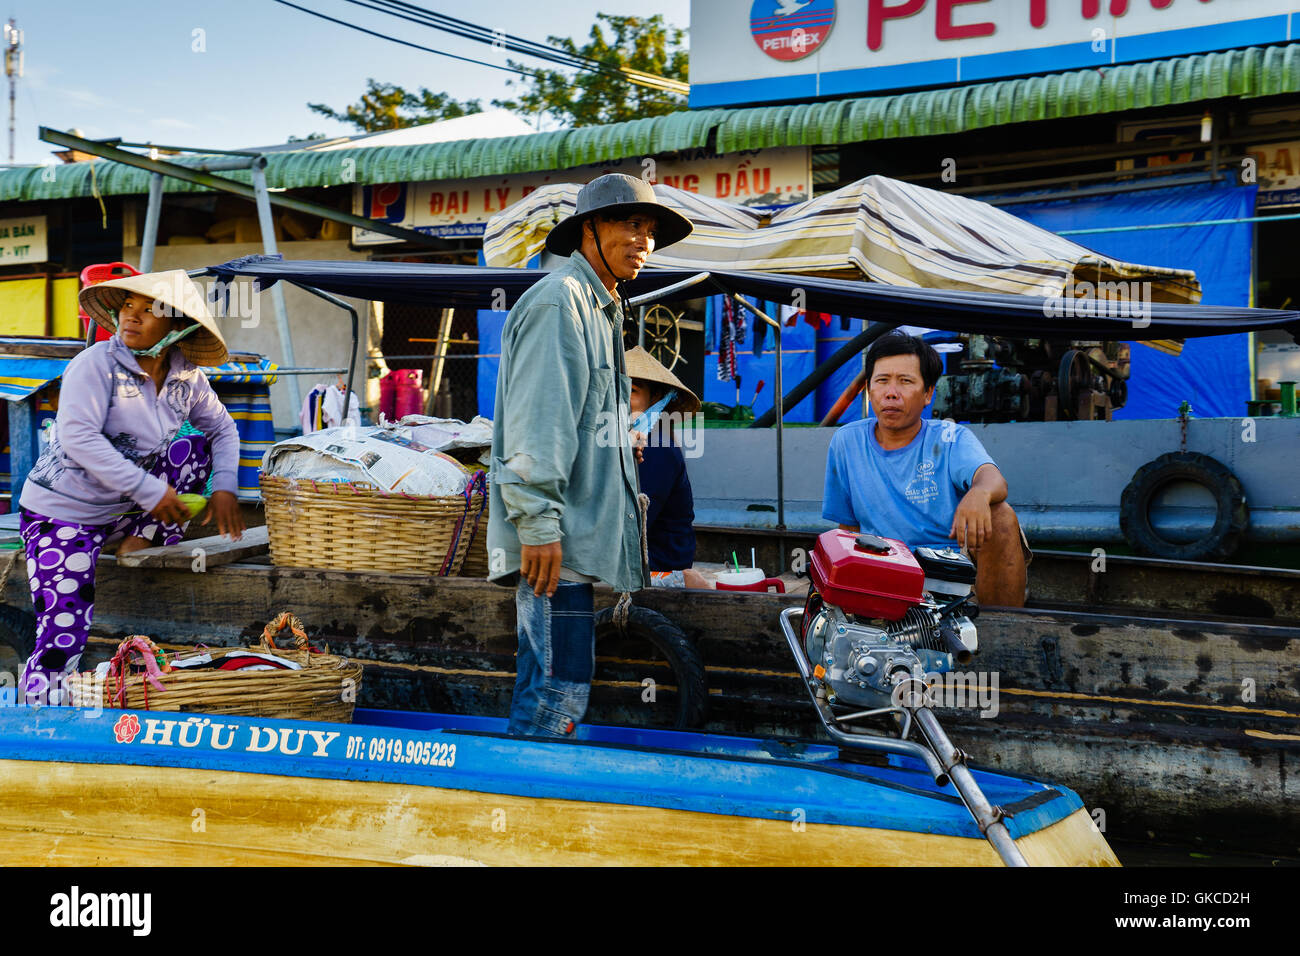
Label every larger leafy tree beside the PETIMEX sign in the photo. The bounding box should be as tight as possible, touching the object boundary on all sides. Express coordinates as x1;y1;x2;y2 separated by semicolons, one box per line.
493;13;689;126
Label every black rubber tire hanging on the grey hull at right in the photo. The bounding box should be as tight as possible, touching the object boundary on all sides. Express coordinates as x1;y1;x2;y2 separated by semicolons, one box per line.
1119;451;1251;561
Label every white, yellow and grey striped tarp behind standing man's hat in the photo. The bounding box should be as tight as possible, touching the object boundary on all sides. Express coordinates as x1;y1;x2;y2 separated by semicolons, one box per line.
484;176;1201;347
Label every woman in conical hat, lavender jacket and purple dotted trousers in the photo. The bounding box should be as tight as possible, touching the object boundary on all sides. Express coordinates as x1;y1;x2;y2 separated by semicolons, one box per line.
20;269;244;704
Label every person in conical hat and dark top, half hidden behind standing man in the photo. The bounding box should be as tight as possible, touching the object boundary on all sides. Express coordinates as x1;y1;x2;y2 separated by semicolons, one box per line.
627;346;709;588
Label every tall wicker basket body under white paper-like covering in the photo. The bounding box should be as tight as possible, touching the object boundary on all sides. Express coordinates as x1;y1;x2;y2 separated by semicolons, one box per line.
260;473;488;575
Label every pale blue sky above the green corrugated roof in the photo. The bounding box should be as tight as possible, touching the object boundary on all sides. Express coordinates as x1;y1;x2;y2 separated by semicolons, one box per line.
0;0;690;164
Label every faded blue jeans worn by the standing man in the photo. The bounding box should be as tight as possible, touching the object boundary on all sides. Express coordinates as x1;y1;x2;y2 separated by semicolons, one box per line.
507;575;595;737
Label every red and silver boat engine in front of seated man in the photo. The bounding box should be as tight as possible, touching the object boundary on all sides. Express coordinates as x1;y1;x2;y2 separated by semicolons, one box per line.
802;531;979;708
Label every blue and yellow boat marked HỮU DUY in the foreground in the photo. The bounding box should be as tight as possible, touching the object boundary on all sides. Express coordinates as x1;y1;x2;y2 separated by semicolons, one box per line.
0;695;1118;866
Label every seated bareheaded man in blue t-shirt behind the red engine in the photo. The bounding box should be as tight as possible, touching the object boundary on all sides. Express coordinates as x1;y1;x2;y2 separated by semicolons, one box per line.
822;332;1030;607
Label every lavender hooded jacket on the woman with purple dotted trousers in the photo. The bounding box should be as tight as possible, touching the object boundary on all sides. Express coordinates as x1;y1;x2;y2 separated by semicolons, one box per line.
20;336;239;524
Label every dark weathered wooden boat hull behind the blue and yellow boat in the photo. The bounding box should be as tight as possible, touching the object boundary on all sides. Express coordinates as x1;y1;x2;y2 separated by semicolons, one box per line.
0;535;1300;855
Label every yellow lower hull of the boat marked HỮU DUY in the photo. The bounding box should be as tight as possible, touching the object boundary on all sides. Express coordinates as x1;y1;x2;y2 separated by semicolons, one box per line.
0;760;1119;866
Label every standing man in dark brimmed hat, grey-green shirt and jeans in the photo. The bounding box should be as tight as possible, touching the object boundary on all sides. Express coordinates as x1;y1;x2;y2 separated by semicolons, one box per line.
488;173;692;736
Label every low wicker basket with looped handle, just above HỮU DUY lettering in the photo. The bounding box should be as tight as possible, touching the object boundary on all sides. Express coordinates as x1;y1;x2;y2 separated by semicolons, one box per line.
68;611;363;723
